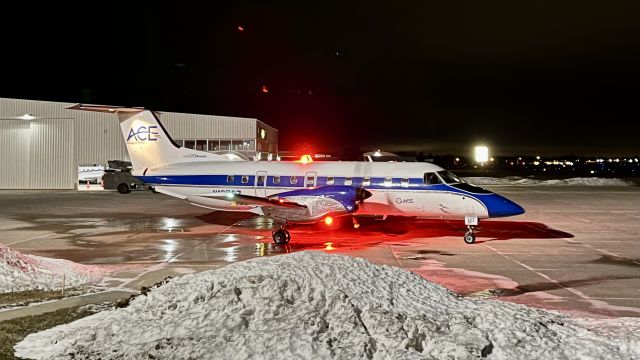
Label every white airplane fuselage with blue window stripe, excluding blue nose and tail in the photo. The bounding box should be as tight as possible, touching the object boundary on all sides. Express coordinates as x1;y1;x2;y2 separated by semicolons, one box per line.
138;161;489;219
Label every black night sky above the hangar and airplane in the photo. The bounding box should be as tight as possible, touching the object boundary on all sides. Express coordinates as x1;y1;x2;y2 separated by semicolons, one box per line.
0;1;640;155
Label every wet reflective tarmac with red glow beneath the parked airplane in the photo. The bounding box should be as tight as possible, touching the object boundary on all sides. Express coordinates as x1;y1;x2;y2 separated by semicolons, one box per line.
0;186;640;316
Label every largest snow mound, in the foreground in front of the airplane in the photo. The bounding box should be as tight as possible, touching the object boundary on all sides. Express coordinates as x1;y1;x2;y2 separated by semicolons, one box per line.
15;251;640;359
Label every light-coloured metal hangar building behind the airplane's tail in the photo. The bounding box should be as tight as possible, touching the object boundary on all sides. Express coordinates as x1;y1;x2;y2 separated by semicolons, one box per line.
0;98;278;189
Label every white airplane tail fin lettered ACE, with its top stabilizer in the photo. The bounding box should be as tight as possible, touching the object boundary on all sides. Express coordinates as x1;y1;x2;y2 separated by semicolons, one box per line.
68;104;241;170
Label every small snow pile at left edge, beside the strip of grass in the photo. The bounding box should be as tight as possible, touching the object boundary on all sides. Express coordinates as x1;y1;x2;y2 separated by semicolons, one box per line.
0;244;104;293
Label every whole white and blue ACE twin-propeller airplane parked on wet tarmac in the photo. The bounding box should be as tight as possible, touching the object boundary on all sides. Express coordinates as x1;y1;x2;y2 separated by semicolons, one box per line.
68;104;525;245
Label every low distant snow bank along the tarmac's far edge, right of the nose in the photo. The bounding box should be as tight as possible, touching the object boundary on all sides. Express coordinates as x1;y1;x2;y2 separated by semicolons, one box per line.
464;176;633;186
